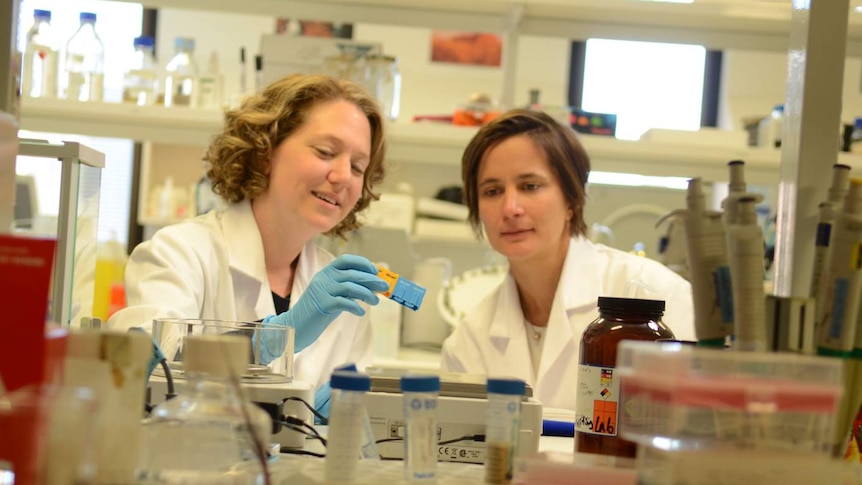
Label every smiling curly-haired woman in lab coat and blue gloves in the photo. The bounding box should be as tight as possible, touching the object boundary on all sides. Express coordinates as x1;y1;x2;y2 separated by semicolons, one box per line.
110;75;389;410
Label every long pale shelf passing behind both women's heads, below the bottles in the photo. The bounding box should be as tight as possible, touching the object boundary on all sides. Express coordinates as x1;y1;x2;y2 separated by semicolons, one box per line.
21;98;862;185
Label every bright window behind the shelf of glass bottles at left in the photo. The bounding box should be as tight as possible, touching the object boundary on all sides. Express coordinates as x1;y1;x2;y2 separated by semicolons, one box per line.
16;0;143;245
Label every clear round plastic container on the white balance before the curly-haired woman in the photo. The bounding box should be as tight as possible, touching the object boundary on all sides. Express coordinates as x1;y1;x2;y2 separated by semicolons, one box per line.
152;318;295;384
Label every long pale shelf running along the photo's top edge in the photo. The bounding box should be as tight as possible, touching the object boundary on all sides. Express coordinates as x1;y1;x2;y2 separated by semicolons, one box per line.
103;0;862;55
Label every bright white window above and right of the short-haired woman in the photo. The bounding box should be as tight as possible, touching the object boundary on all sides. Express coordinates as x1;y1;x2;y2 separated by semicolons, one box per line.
581;39;706;140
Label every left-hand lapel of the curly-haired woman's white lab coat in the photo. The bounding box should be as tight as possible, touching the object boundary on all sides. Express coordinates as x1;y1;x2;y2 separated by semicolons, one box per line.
222;201;275;318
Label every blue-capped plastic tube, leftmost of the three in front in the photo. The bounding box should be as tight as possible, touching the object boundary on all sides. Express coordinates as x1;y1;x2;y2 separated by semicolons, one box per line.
325;371;371;482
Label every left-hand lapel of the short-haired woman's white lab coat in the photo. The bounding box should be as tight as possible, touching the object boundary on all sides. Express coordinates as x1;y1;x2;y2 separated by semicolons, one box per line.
488;273;535;386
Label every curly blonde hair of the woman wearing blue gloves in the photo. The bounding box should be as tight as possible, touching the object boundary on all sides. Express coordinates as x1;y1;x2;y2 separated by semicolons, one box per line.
204;74;386;238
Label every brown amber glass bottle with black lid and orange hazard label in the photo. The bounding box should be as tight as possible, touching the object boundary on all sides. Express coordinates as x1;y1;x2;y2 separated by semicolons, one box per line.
575;297;674;458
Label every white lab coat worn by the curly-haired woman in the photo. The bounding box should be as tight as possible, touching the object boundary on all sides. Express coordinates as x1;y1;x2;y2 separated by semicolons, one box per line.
109;202;373;386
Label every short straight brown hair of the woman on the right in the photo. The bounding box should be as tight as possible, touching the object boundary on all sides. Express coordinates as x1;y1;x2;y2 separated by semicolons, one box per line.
461;109;590;237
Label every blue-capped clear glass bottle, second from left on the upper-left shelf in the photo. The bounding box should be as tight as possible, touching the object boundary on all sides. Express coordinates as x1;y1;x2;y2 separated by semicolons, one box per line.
64;12;105;101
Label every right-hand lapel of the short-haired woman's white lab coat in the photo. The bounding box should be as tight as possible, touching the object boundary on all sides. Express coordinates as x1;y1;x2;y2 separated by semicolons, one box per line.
536;238;602;390
